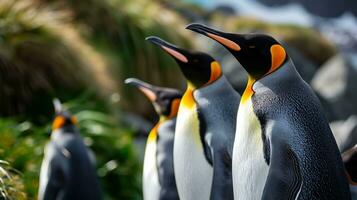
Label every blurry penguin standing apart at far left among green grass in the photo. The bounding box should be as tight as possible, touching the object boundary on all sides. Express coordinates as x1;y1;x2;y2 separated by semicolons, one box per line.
38;99;102;200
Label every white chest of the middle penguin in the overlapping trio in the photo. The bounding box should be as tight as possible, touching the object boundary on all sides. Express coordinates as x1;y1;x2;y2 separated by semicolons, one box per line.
174;107;213;200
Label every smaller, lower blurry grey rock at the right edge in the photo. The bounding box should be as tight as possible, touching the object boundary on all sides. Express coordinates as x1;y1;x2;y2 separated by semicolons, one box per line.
330;115;357;152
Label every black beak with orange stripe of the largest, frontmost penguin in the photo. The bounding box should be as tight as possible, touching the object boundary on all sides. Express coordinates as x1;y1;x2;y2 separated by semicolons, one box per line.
186;23;241;51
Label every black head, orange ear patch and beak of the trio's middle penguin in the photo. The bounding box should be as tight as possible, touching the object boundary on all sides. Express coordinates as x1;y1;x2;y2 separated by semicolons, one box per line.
146;37;222;88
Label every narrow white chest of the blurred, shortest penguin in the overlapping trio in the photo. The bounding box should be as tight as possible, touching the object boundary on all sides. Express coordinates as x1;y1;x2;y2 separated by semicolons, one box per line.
143;138;160;200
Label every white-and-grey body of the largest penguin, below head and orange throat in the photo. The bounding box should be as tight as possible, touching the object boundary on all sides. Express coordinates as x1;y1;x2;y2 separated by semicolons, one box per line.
233;62;349;199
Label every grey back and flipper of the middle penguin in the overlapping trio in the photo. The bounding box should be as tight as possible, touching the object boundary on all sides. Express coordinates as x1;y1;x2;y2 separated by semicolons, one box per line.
194;76;240;199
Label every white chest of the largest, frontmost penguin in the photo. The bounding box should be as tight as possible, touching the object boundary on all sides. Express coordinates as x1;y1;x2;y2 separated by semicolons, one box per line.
232;99;269;200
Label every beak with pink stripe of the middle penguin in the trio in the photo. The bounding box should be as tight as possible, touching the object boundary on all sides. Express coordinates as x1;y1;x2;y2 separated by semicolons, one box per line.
145;36;189;63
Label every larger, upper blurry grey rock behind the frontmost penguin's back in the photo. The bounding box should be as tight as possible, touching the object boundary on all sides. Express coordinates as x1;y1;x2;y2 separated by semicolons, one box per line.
311;55;357;119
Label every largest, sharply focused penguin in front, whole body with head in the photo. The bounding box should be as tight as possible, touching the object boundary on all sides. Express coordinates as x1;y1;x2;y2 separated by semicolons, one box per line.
186;24;350;200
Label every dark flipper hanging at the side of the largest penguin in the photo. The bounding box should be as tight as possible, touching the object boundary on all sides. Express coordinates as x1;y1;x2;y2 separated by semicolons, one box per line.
262;128;302;200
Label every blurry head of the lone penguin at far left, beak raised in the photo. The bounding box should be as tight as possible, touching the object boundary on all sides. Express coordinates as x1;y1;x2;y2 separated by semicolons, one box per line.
52;99;77;131
